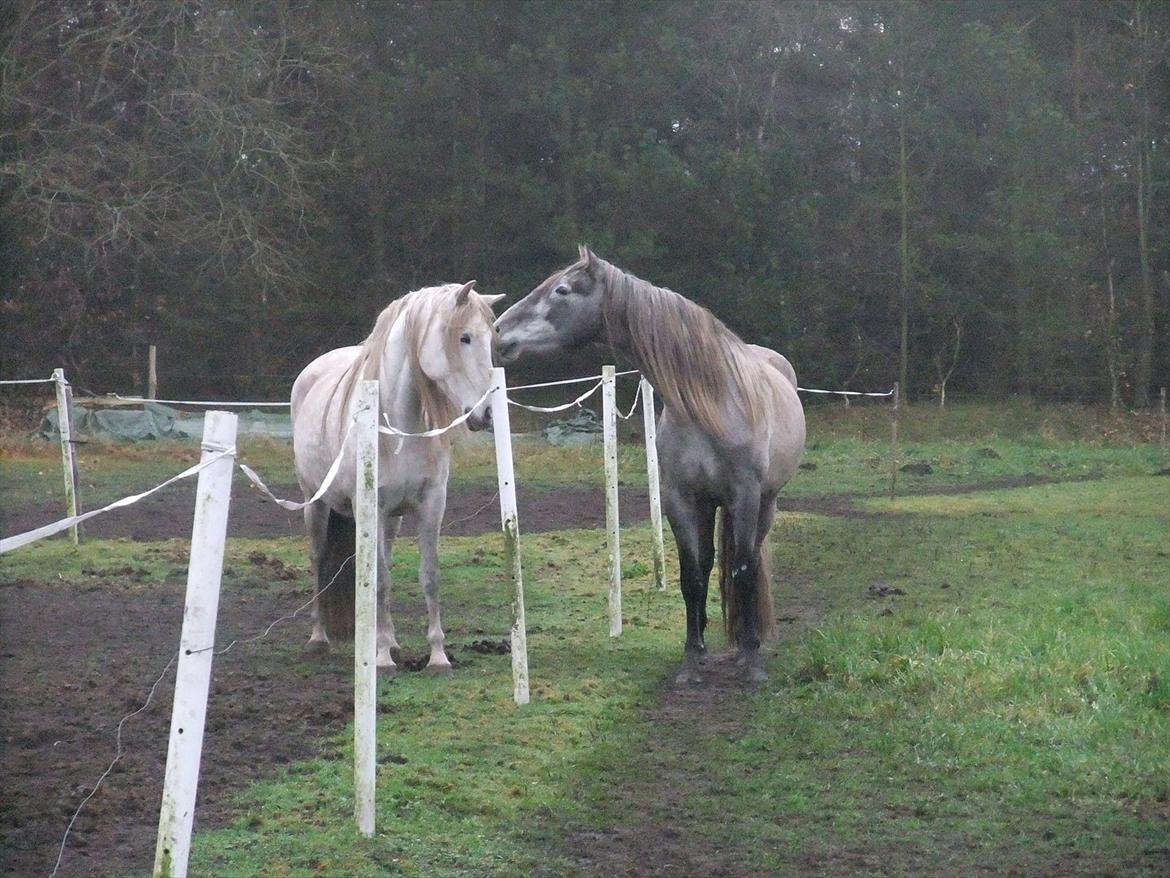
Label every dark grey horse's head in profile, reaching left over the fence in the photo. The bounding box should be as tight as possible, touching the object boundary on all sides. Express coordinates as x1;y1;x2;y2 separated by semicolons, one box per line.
496;247;605;364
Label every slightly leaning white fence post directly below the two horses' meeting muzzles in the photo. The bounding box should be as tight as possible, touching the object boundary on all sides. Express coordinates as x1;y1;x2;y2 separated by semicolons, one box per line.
491;366;529;705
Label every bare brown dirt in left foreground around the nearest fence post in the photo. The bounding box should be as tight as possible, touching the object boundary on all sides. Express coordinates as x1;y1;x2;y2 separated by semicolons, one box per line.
0;579;341;876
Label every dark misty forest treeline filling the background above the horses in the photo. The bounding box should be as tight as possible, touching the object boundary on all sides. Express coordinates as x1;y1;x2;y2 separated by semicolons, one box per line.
0;0;1170;406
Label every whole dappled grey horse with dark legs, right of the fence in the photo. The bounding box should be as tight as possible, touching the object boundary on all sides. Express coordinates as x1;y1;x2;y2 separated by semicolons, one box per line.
496;247;805;684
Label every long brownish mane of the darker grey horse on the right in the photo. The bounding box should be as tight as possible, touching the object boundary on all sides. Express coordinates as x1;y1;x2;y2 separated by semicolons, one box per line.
592;256;770;440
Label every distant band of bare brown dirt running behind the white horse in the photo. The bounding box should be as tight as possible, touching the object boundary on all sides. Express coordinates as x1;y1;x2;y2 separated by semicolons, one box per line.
0;483;651;542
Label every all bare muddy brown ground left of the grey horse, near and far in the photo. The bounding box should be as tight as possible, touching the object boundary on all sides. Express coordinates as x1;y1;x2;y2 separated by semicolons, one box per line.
0;486;648;878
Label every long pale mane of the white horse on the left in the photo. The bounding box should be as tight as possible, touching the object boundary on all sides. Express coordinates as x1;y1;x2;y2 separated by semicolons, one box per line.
323;283;493;443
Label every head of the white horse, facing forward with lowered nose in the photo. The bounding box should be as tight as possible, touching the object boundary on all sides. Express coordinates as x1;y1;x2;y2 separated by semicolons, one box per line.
414;281;503;430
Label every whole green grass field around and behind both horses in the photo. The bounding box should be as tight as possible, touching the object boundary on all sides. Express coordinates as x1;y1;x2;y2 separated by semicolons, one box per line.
0;407;1170;876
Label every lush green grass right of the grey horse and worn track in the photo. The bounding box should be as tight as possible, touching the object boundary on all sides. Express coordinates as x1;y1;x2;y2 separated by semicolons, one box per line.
683;478;1170;873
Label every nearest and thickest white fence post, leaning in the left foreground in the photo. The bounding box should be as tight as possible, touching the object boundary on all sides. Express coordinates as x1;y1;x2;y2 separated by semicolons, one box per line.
154;412;236;878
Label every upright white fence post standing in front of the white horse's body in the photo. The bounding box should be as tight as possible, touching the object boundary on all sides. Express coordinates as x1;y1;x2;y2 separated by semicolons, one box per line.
353;380;378;838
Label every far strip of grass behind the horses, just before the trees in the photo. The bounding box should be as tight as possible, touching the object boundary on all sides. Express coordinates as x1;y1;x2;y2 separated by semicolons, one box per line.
0;400;1170;509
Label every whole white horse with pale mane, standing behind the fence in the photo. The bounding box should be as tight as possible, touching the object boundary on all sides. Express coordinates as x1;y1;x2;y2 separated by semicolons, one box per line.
293;281;502;672
